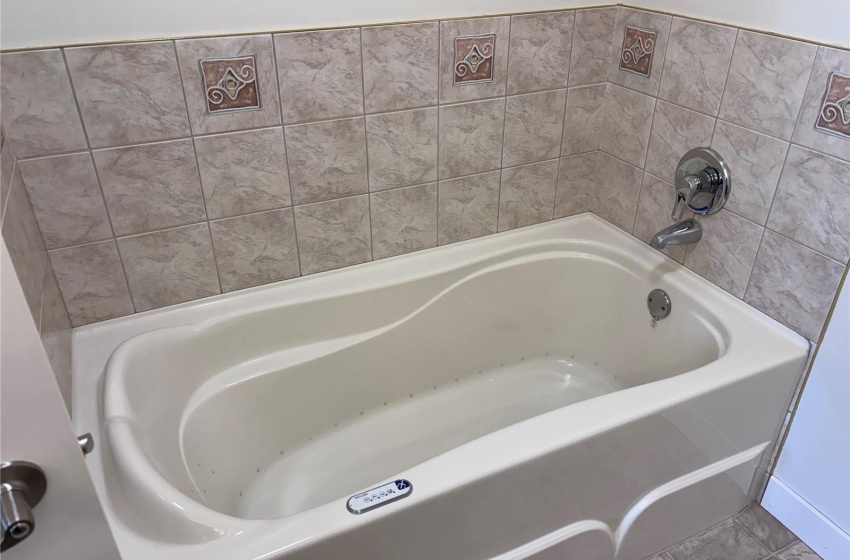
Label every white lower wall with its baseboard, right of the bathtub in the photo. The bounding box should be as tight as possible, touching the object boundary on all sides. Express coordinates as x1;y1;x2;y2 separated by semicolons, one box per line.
764;281;850;560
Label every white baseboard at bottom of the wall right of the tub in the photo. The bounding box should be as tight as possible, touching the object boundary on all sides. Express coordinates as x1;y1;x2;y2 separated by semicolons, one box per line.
761;476;850;560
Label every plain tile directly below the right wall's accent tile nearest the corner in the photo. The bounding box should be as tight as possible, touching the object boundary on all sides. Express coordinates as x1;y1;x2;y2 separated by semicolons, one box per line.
600;84;655;167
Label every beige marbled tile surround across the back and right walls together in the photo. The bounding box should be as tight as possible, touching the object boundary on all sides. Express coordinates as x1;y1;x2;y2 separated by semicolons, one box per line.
0;7;850;339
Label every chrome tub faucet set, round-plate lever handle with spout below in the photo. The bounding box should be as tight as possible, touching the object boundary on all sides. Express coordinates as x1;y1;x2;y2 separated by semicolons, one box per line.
650;148;732;249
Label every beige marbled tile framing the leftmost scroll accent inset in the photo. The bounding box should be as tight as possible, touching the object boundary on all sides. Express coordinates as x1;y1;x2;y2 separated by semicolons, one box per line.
174;35;280;134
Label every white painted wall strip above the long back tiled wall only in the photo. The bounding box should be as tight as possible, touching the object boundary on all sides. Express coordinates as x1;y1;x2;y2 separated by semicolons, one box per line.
0;0;576;49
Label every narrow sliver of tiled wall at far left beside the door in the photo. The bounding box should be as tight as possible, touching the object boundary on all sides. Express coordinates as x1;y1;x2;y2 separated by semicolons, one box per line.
0;127;71;412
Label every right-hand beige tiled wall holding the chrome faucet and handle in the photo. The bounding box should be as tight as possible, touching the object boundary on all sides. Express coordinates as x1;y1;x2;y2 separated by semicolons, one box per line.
576;7;850;341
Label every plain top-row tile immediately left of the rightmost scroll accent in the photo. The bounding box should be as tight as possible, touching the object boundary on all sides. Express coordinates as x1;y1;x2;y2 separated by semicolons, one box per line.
720;30;817;140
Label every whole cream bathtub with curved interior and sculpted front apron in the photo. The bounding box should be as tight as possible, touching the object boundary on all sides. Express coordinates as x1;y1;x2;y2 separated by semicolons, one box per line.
74;214;808;560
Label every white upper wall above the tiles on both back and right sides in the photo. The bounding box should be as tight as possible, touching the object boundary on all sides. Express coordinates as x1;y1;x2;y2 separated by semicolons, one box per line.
0;0;850;49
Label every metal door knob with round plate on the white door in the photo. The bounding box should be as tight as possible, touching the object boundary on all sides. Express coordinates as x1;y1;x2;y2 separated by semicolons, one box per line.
0;461;47;551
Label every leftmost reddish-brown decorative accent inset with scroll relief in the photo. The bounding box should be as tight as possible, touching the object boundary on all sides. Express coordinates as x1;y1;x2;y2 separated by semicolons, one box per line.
199;55;260;114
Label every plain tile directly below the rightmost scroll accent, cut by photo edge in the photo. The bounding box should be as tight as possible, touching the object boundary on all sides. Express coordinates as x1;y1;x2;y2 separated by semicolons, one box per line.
767;145;850;263
